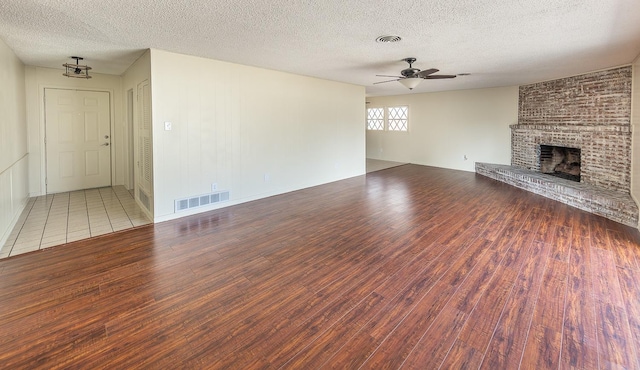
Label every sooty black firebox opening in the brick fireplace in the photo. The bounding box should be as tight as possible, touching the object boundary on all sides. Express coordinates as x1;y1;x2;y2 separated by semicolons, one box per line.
540;145;580;182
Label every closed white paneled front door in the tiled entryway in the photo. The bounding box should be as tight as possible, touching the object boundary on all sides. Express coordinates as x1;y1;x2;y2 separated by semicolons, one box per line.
45;89;111;193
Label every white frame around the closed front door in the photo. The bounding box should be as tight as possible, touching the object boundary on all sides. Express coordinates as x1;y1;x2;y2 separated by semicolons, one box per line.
38;85;120;195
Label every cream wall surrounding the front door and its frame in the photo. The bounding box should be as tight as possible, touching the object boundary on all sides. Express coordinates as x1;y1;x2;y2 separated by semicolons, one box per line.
25;63;127;196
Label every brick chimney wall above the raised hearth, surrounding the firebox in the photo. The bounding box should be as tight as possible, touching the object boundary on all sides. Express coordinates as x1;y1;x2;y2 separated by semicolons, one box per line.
511;67;631;192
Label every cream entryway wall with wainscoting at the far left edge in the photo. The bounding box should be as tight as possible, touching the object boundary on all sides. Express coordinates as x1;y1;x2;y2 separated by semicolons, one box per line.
0;40;28;248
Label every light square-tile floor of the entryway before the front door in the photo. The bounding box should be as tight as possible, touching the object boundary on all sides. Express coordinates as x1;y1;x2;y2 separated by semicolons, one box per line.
0;186;151;258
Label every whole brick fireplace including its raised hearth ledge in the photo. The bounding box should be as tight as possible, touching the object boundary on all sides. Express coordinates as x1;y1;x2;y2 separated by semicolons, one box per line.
476;66;638;227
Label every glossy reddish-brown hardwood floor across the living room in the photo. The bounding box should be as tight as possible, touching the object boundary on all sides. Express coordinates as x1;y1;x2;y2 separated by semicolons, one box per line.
0;165;640;369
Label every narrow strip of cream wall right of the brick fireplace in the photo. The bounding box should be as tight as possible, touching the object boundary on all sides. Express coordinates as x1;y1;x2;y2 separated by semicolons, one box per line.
631;55;640;227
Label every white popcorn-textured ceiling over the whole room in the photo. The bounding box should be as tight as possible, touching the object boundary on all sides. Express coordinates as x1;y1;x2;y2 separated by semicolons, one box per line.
0;0;640;96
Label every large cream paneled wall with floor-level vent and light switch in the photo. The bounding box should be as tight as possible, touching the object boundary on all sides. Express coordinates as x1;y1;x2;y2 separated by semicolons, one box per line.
151;49;365;221
